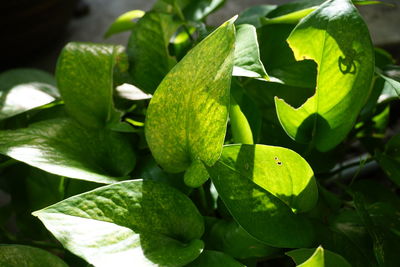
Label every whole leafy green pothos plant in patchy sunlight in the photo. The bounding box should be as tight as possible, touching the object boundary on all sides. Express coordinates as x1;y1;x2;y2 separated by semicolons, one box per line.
0;0;400;267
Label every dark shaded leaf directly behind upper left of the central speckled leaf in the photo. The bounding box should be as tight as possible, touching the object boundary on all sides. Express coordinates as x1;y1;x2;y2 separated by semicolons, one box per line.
127;12;179;93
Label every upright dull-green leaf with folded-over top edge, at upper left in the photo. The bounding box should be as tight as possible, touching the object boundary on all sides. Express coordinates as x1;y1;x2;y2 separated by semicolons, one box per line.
56;43;122;128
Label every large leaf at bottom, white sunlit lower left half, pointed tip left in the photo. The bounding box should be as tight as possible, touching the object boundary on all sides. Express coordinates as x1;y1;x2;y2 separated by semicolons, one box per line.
33;180;204;267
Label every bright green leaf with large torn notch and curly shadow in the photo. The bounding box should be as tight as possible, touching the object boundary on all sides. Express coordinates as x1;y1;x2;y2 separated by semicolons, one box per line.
275;0;374;151
